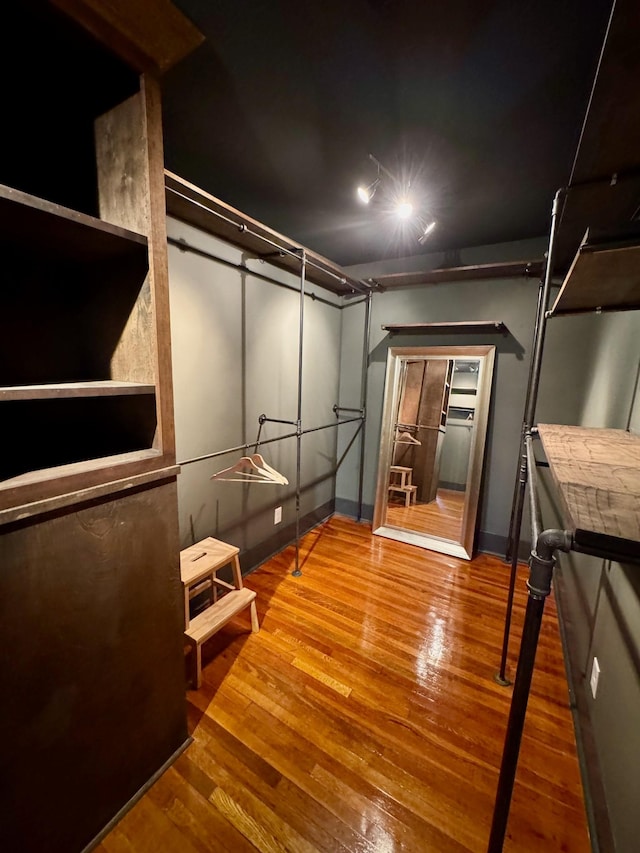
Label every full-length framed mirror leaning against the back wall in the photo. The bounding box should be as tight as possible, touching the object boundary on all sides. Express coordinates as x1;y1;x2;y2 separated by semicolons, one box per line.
373;346;495;559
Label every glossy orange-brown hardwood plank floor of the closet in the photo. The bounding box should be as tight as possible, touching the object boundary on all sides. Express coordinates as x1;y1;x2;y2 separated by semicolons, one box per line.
97;516;591;853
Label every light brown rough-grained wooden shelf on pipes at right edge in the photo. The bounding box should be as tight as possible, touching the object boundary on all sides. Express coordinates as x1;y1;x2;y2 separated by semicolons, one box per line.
538;424;640;562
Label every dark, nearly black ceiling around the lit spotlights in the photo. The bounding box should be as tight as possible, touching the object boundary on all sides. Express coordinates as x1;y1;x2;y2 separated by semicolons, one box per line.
163;0;612;265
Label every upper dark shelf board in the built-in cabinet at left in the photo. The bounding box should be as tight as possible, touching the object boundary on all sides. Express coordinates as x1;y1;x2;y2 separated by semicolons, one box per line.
0;184;147;264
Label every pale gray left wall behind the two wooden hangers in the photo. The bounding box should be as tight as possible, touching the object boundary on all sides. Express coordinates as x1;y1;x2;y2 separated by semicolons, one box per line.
168;219;341;570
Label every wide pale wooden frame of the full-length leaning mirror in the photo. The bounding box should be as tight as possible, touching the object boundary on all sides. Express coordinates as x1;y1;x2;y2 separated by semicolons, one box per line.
372;346;496;560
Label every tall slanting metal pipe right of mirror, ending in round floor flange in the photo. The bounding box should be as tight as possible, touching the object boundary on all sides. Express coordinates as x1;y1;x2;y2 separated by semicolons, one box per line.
496;188;565;685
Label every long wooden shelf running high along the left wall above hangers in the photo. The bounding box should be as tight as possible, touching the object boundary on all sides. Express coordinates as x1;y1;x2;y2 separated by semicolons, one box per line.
165;170;371;296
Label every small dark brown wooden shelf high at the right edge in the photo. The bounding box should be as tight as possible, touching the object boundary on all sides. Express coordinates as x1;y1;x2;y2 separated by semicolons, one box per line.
549;230;640;317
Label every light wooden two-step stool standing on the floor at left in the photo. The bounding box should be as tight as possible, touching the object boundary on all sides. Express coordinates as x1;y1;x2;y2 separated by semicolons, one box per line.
180;536;260;689
